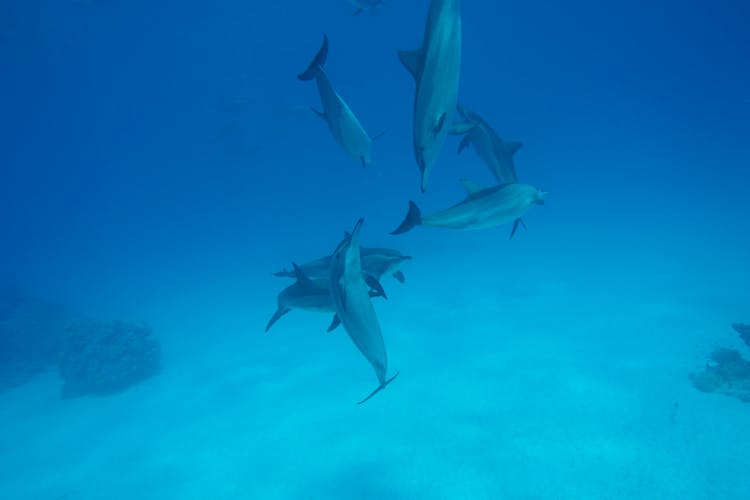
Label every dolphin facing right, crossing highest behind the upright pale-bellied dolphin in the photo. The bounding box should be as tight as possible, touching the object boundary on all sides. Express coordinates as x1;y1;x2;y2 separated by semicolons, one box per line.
273;247;411;288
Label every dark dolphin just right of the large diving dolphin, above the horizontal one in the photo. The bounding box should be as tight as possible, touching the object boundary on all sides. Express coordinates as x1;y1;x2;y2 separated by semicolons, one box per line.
451;104;523;184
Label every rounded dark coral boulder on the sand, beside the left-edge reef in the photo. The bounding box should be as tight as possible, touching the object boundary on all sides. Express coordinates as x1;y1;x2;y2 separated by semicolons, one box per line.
59;321;161;398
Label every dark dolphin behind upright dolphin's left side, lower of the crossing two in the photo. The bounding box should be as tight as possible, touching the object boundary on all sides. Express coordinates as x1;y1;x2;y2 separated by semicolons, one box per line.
266;263;385;332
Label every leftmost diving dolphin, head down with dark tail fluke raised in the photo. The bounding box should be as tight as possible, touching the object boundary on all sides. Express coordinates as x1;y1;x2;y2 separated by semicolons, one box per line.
297;35;372;166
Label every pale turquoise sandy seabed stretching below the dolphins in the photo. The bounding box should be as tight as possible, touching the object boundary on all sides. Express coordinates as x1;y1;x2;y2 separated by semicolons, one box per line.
0;254;750;500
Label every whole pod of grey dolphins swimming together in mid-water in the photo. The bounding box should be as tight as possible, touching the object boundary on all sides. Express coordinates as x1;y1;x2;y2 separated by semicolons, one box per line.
266;0;547;404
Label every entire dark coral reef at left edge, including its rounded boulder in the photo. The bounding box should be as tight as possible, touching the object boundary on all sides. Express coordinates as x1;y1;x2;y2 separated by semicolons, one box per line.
0;288;161;397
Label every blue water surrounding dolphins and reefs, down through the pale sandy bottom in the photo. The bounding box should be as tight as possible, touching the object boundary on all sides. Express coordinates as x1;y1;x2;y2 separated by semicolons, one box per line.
0;0;750;500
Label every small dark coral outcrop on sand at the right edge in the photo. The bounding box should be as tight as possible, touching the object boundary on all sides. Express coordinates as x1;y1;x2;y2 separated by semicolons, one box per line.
690;325;750;403
